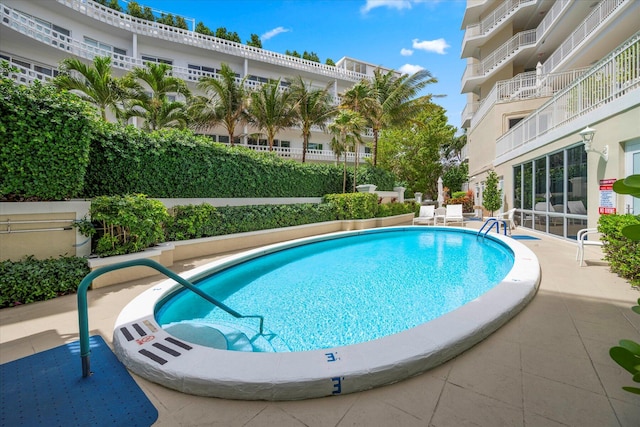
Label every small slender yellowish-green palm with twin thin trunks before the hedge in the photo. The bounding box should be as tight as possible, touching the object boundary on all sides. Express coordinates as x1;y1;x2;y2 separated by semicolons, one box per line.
328;109;366;193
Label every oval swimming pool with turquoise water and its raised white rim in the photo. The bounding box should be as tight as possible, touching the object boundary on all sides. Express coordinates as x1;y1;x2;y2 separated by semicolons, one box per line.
114;227;540;400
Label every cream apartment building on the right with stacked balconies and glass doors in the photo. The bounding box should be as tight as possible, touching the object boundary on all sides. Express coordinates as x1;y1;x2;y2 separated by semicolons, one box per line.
462;0;640;239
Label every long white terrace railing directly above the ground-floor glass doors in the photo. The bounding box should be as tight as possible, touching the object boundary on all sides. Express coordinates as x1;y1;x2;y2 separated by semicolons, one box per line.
496;32;640;158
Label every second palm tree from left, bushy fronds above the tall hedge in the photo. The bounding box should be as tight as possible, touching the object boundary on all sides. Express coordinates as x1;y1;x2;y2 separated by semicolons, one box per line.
125;62;191;130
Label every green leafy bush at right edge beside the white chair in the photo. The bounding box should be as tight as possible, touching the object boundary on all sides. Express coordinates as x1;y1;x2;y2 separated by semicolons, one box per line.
598;214;640;286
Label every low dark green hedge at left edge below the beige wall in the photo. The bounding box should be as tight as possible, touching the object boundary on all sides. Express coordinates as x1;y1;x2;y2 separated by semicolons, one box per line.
0;256;89;307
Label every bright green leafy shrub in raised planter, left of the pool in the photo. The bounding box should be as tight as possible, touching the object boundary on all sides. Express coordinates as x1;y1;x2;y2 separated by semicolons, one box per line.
89;194;169;256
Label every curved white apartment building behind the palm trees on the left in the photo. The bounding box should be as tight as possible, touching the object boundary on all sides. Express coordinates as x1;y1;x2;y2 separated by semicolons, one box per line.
0;0;386;162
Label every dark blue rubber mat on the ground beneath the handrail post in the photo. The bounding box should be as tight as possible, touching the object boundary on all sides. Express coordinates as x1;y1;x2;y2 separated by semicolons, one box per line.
0;335;158;427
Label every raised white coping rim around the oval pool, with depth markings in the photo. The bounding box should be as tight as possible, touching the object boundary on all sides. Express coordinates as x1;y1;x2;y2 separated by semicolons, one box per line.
113;226;540;400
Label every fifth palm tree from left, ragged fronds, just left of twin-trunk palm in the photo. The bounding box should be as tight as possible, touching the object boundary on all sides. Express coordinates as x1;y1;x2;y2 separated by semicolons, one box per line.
289;76;337;163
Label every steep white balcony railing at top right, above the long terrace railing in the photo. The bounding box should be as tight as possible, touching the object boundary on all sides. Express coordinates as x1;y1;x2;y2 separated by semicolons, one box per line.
542;0;634;74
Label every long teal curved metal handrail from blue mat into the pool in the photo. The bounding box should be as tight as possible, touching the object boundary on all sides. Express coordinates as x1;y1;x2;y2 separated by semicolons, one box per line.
78;259;264;377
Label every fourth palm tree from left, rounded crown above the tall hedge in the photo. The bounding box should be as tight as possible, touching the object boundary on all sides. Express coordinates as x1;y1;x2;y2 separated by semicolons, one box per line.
248;79;297;151
